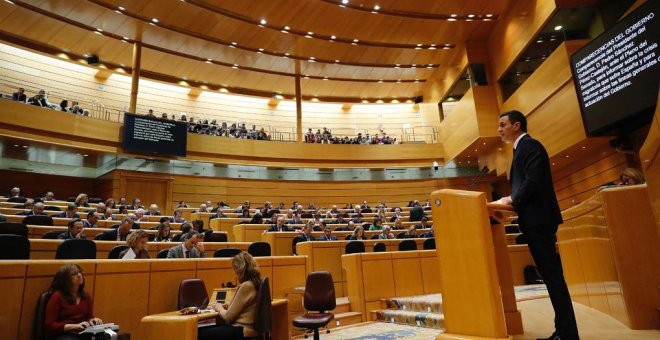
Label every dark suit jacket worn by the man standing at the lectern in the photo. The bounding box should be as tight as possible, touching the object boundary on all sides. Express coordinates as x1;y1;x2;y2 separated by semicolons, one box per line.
510;135;563;234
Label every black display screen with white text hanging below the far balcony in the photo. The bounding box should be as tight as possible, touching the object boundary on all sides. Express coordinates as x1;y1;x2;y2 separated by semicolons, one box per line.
122;112;188;157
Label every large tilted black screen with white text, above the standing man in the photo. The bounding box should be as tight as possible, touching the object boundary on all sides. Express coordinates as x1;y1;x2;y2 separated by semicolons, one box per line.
571;1;660;136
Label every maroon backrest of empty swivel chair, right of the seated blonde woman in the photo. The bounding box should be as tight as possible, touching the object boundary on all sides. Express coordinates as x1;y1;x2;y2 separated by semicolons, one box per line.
304;272;337;313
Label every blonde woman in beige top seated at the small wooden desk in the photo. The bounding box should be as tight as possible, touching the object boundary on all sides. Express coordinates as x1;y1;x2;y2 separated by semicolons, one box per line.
198;252;261;340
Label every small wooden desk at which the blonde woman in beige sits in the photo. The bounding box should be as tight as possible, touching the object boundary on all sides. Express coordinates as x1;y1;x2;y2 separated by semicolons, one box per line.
139;299;290;340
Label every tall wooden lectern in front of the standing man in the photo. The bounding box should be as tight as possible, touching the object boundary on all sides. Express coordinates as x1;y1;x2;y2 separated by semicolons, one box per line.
431;189;523;340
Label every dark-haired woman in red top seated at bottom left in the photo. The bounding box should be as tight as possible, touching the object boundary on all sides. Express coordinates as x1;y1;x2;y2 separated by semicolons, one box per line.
44;263;103;340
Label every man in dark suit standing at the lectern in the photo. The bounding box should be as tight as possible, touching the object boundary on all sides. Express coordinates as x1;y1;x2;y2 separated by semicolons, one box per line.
497;110;579;340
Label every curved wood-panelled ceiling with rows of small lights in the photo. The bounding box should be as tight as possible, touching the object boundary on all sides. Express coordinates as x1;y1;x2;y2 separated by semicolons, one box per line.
0;0;511;101
